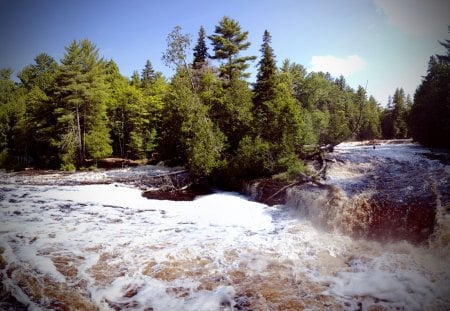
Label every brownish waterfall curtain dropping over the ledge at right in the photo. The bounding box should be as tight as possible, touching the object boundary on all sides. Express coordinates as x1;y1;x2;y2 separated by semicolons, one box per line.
286;185;436;244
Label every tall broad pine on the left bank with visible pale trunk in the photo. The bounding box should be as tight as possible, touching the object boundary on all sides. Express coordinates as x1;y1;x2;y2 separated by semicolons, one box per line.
55;39;112;169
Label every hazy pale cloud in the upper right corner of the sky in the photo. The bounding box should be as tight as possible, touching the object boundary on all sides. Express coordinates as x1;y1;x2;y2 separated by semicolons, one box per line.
374;0;450;39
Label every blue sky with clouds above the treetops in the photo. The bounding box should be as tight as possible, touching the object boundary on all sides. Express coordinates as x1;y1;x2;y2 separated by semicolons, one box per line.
0;0;450;105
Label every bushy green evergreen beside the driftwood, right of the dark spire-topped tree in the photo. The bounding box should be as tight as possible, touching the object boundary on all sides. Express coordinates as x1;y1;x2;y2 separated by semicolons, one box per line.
231;74;305;178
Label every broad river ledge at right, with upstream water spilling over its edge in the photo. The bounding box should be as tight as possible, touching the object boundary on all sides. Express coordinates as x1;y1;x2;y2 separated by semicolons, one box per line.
245;143;450;245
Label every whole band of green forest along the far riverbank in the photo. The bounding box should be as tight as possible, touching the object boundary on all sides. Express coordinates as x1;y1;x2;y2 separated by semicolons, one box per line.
0;16;450;183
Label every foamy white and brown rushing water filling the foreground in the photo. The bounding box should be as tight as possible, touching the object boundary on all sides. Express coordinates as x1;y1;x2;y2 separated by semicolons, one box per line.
0;145;450;310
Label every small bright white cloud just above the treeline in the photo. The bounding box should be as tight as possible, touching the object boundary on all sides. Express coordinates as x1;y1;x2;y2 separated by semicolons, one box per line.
311;55;367;76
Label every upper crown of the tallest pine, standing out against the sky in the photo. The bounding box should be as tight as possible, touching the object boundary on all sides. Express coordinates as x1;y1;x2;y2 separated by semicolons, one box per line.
208;16;256;81
